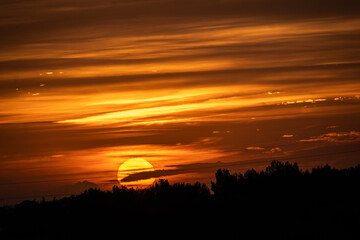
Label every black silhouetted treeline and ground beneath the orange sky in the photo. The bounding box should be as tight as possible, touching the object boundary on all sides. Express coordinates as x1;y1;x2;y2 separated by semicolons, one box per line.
0;161;360;239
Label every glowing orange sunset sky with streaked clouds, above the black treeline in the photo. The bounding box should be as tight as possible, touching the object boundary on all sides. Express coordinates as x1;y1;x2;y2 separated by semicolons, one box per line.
0;0;360;204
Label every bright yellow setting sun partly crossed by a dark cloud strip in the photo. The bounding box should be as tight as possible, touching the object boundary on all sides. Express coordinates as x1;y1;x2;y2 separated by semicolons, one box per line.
117;158;155;188
